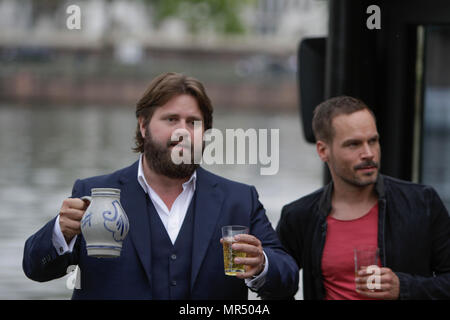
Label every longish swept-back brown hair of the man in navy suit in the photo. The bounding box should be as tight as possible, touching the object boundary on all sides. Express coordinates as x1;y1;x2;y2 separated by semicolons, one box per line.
133;72;213;152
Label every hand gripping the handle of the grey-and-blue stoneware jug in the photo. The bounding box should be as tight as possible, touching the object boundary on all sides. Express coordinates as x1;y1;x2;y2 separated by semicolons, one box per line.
59;198;89;243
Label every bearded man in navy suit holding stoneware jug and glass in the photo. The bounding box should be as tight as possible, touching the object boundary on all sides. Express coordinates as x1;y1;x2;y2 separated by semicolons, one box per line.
23;73;298;300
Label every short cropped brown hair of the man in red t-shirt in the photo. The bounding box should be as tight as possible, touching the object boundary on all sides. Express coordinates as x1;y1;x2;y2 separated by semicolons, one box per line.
312;96;375;143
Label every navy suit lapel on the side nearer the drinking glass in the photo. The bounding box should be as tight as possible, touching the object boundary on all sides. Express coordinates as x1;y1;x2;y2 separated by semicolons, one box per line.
191;168;224;290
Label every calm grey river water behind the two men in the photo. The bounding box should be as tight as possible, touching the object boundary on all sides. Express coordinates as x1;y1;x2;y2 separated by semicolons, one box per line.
0;105;322;299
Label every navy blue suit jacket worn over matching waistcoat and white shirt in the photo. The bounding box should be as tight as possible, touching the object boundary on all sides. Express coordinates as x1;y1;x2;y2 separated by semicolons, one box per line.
23;161;298;300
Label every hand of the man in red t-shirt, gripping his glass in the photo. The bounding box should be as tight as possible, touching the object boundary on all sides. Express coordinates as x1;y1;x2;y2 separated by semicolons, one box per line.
355;268;400;300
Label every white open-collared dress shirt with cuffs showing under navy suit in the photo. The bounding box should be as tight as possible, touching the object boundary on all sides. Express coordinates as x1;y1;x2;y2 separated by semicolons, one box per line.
52;154;269;290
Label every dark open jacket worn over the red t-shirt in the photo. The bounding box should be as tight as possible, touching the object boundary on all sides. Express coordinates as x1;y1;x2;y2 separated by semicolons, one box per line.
277;175;450;299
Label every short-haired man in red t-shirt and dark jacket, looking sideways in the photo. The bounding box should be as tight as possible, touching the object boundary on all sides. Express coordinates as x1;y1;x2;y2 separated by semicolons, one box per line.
277;96;450;300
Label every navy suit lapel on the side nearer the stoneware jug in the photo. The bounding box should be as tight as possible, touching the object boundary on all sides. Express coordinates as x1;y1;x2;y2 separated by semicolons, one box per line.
120;162;152;288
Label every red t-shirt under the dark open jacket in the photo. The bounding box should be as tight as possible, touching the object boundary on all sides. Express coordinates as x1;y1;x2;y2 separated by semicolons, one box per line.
322;203;378;300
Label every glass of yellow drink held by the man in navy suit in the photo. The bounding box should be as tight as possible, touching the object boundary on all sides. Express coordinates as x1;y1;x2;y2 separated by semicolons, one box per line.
222;226;248;276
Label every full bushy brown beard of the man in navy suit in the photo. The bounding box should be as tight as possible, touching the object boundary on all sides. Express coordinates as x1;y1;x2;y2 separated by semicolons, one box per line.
144;128;199;179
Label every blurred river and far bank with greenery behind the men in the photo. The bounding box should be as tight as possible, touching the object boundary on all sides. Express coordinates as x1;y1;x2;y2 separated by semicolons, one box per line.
0;0;329;299
